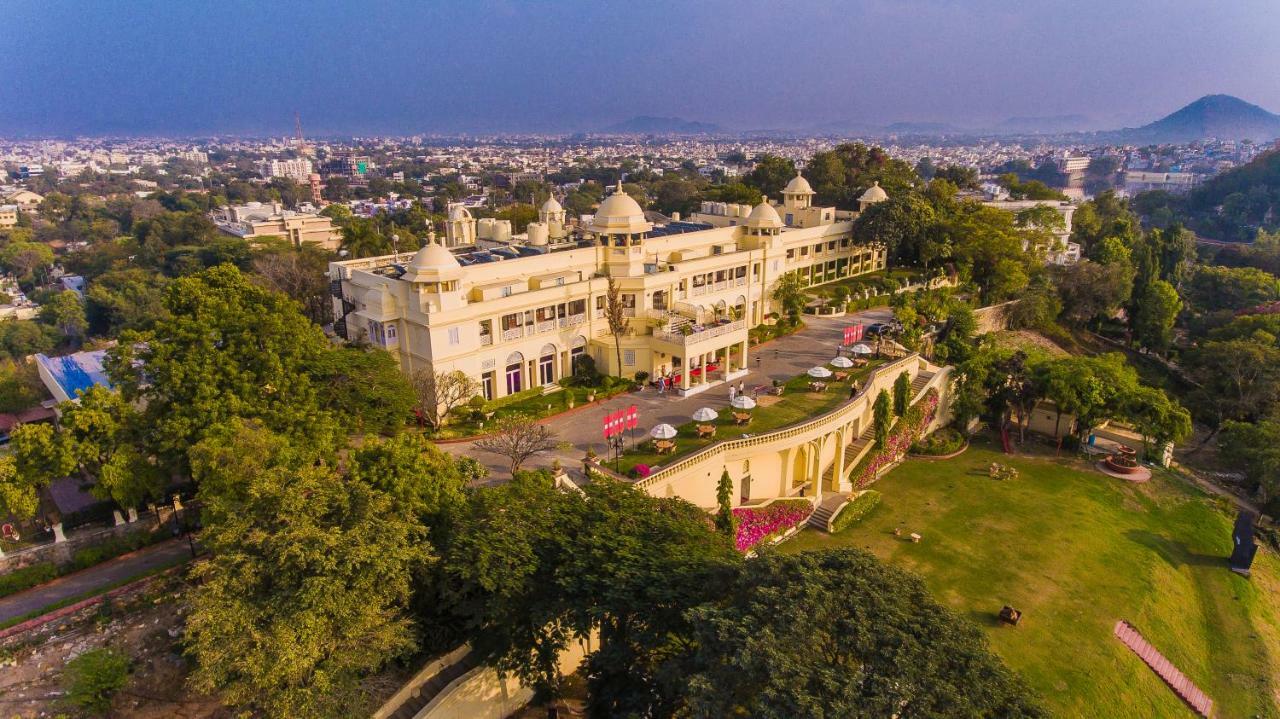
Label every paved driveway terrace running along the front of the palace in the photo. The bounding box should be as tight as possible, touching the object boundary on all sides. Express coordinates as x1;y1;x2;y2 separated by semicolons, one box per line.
440;307;892;481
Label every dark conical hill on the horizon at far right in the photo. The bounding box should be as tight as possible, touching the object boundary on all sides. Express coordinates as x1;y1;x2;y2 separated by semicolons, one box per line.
1117;95;1280;143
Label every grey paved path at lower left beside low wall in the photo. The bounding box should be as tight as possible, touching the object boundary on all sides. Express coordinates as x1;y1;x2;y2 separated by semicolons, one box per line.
0;539;191;623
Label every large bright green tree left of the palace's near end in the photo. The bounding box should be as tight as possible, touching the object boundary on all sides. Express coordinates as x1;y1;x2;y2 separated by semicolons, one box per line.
108;265;338;473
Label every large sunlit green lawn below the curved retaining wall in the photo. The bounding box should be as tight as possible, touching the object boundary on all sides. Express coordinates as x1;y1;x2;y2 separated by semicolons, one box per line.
780;443;1280;718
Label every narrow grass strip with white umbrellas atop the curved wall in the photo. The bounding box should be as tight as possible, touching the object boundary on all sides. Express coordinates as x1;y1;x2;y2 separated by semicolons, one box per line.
614;360;884;473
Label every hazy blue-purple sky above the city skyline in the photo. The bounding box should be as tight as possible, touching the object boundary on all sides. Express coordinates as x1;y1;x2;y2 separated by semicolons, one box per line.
0;0;1280;136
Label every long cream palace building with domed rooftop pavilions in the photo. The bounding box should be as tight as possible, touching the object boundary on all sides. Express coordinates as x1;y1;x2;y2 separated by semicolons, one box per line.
329;175;886;399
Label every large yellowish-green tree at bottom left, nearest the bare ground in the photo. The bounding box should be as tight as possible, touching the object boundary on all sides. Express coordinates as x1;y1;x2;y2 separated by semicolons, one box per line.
186;421;430;718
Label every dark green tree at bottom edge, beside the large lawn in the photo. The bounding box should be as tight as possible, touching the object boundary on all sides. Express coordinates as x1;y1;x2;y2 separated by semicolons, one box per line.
684;549;1044;719
